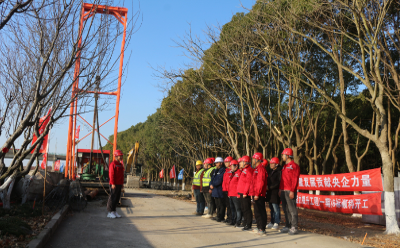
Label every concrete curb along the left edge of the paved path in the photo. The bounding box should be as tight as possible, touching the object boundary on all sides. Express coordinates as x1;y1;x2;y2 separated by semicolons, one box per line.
27;204;69;248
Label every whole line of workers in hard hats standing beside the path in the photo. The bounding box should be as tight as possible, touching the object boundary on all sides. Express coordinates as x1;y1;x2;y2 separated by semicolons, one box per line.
192;148;300;236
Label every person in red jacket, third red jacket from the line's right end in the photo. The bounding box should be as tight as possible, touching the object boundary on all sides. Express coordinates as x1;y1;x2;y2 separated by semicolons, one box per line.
237;156;254;231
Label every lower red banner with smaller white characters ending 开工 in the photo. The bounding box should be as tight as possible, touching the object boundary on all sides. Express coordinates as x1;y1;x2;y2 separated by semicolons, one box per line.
296;192;382;215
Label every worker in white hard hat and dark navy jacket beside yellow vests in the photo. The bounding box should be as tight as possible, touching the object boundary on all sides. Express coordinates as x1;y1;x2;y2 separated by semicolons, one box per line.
210;157;226;222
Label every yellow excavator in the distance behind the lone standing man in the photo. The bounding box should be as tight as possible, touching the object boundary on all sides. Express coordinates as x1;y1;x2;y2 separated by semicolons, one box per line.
125;141;142;188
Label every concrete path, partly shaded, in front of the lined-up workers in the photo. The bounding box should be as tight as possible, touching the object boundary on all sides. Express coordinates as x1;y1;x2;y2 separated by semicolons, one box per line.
46;190;368;248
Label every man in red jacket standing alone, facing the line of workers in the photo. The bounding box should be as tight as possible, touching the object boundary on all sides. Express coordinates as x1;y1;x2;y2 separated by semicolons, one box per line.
107;150;124;219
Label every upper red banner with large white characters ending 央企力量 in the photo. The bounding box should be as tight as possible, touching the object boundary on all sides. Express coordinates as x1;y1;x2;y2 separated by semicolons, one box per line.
298;168;383;191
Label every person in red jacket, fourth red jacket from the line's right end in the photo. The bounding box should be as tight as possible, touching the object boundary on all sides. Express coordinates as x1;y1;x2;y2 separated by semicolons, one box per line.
225;160;242;228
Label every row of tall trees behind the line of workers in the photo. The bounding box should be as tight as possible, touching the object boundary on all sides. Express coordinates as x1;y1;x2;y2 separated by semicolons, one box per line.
111;0;400;233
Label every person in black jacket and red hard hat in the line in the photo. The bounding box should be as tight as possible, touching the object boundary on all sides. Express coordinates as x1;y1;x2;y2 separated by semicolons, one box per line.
265;157;282;230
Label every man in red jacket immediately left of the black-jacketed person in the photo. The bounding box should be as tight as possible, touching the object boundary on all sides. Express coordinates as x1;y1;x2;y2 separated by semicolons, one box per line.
250;152;268;236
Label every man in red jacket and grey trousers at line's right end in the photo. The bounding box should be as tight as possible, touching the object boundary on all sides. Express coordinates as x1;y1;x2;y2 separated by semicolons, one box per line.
279;148;300;235
